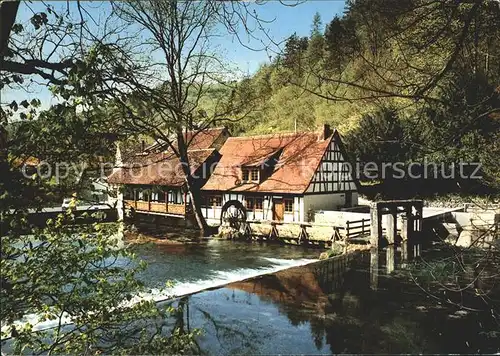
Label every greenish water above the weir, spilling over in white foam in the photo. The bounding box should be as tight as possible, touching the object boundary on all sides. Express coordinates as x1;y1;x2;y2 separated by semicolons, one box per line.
135;240;320;300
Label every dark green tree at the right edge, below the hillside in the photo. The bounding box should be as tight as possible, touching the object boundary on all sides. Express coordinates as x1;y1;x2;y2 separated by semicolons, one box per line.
421;74;500;186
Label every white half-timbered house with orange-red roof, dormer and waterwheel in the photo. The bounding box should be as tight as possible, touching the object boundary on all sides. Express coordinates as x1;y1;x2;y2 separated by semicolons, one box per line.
202;125;358;225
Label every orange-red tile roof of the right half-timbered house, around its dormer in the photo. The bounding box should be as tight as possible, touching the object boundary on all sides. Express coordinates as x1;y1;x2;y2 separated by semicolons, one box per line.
203;132;335;194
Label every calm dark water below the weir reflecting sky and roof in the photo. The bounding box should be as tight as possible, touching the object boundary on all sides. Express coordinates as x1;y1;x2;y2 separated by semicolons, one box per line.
166;242;494;355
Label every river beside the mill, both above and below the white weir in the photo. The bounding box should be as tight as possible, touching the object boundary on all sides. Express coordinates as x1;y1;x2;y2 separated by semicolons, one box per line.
130;241;500;355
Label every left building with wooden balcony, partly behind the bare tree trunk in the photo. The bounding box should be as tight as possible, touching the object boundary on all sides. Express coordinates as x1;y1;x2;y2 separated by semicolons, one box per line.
108;128;229;218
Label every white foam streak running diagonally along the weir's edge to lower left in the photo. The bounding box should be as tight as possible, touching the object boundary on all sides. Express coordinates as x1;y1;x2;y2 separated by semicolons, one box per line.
1;257;317;331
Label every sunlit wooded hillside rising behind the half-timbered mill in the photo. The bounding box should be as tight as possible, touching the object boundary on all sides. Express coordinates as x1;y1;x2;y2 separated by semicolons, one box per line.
222;0;500;192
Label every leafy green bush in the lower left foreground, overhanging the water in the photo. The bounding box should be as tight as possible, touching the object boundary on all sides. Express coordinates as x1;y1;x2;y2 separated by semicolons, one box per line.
0;209;197;354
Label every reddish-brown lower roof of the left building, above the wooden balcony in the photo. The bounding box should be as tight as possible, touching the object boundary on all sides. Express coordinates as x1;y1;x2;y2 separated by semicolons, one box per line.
108;148;215;187
